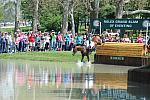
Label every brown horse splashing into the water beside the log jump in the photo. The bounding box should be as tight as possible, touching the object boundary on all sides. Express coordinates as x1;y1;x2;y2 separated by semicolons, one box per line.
72;42;94;62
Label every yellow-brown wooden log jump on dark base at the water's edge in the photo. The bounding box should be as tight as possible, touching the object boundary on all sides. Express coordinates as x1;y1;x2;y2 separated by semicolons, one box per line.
94;42;150;66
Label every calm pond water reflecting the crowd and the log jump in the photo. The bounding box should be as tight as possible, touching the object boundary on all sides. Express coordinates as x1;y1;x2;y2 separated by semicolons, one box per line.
0;60;150;100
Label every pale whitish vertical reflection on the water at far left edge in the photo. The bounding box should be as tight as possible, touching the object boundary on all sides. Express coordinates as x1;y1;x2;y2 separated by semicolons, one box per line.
0;63;14;100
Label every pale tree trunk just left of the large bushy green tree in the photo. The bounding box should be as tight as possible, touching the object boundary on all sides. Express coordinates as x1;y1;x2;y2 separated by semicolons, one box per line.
32;0;39;33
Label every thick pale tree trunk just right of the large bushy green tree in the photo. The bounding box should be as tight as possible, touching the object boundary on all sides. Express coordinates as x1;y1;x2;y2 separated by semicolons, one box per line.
62;0;69;34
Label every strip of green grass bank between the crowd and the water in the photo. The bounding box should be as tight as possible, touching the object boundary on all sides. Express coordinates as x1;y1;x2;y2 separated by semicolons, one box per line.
0;51;94;62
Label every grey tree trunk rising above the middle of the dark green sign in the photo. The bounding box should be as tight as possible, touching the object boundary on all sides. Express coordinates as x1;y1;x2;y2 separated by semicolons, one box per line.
116;0;124;19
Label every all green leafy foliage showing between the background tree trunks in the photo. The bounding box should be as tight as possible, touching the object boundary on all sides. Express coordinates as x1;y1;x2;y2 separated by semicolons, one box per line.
19;0;150;31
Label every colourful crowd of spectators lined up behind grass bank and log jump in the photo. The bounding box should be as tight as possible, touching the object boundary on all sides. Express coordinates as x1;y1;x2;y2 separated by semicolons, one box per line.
0;30;148;53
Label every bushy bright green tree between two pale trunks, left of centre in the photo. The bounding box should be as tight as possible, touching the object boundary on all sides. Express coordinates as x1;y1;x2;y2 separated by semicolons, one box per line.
39;0;63;31
